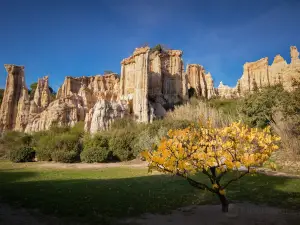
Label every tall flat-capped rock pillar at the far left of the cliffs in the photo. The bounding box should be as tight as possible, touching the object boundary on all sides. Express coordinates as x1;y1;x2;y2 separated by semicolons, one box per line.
0;64;30;131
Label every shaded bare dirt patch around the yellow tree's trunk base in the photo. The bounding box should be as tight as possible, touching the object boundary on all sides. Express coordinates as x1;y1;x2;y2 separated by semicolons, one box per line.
119;203;300;225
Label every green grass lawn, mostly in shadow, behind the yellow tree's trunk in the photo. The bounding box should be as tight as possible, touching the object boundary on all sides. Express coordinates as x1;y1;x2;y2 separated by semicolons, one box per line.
0;161;300;223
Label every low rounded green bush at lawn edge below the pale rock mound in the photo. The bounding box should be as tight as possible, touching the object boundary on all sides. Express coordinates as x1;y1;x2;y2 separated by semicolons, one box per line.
80;147;112;163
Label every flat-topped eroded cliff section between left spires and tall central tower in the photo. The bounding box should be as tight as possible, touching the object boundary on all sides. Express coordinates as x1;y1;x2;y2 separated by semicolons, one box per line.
25;74;119;132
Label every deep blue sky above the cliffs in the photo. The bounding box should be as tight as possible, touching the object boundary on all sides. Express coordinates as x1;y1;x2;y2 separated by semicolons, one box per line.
0;0;300;89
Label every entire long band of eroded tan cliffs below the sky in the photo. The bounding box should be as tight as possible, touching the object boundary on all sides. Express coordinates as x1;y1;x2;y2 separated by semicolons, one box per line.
0;46;300;133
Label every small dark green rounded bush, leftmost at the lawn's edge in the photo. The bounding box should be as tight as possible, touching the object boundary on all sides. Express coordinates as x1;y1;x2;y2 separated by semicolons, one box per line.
9;147;35;163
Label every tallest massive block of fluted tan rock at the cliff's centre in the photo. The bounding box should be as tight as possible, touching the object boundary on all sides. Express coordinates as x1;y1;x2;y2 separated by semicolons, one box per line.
120;47;187;122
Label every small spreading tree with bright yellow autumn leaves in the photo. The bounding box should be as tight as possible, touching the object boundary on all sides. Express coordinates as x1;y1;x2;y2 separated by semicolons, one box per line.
142;121;280;212
